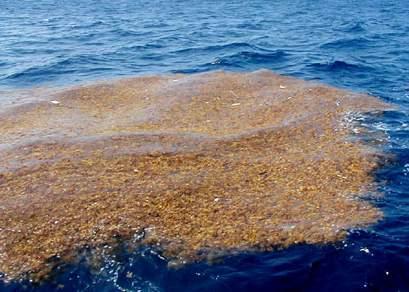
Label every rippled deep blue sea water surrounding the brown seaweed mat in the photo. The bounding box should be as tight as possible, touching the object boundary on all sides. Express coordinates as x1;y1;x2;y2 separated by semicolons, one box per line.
0;0;409;291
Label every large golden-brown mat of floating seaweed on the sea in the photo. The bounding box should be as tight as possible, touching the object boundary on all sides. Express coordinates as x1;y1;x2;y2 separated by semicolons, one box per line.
0;70;388;280
